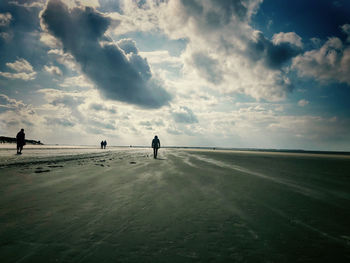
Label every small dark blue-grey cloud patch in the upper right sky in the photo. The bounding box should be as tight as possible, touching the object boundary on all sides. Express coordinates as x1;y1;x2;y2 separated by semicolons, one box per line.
246;32;302;69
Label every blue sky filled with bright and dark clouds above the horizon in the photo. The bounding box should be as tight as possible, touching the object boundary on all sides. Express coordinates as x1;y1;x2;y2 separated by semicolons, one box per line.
0;0;350;151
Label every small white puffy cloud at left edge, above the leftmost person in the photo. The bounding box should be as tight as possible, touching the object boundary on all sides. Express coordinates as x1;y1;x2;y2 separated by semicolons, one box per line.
0;58;36;81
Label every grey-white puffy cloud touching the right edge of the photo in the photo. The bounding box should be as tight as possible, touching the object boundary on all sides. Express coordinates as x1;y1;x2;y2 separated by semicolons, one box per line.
292;37;350;85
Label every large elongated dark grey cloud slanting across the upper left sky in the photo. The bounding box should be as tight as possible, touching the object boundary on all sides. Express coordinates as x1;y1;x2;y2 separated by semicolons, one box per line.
41;0;171;108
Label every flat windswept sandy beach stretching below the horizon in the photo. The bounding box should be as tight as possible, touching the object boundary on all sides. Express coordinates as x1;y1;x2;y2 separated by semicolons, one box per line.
0;146;350;262
